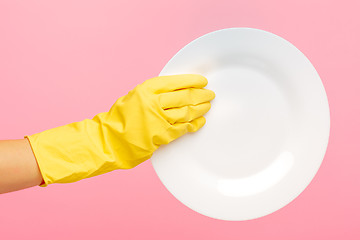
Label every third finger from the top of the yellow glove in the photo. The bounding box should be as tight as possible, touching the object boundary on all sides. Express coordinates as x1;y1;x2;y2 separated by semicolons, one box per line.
164;102;211;124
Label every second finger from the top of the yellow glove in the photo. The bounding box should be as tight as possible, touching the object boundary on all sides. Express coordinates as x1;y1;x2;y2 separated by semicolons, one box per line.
159;88;215;109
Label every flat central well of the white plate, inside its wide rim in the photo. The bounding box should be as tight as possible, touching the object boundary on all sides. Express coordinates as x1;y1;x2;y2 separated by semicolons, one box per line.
194;63;290;178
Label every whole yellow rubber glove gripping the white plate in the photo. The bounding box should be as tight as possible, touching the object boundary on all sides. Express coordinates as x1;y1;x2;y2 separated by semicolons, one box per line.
24;74;215;187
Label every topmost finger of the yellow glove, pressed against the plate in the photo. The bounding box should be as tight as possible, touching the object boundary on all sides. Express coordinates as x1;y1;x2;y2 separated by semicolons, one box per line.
147;74;208;93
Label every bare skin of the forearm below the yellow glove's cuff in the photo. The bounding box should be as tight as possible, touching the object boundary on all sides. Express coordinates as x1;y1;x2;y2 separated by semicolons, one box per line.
0;138;43;193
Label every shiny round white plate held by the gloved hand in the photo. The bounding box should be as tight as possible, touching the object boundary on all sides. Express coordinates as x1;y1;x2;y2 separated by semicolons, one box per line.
152;28;330;220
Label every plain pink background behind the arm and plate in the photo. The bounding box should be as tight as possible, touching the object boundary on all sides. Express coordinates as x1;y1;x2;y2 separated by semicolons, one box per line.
0;0;360;240
